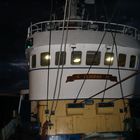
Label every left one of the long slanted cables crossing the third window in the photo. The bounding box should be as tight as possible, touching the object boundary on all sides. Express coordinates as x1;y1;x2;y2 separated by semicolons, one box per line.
49;0;68;121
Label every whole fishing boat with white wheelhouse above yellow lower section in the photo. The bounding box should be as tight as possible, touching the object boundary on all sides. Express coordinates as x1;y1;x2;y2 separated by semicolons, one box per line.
26;0;140;140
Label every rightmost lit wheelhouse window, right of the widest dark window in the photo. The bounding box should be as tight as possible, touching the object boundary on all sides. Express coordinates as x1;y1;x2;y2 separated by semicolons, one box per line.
104;52;114;65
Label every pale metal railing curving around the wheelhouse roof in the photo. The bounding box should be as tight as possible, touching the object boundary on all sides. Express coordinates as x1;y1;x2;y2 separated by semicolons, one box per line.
27;20;140;40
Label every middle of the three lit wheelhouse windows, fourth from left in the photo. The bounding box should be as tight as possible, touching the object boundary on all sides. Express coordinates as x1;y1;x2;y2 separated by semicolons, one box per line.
71;51;82;65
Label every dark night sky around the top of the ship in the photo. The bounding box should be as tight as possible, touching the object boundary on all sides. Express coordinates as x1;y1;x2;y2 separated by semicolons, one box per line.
0;0;140;92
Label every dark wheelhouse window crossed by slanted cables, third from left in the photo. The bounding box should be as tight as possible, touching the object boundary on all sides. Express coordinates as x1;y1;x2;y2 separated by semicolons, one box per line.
55;51;66;65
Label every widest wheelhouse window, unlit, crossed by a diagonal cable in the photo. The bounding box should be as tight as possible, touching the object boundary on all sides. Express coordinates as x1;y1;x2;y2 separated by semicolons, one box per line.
86;51;101;65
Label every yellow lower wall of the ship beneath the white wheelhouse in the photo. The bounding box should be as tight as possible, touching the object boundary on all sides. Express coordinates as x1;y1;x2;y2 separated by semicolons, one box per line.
31;99;130;135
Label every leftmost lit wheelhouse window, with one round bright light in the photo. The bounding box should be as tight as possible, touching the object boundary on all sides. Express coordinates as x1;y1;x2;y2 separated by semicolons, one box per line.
40;52;51;66
